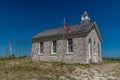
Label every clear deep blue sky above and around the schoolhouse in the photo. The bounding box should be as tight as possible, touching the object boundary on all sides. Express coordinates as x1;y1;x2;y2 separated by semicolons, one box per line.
0;0;120;57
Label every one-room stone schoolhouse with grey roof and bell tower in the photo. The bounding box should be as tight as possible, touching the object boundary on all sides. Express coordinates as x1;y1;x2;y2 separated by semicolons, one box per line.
32;12;102;64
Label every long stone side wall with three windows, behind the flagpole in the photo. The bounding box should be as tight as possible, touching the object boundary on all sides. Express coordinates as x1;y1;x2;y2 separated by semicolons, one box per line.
32;37;86;63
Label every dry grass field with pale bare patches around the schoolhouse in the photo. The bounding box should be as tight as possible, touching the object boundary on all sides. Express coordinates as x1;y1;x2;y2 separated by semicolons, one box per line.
0;58;120;80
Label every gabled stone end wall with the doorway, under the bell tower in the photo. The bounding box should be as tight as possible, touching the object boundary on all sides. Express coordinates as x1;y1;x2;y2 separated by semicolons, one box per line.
85;28;102;63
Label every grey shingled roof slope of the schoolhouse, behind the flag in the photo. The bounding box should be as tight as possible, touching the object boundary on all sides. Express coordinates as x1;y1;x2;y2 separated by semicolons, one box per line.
32;22;95;39
